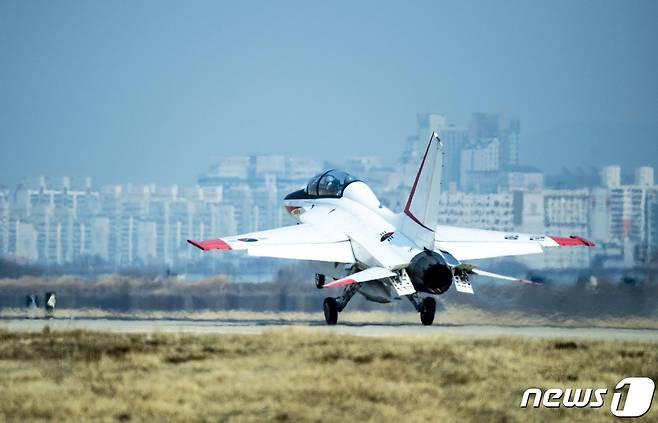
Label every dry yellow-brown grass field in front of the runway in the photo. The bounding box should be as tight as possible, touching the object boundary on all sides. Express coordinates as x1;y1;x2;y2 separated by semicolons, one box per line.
0;328;658;422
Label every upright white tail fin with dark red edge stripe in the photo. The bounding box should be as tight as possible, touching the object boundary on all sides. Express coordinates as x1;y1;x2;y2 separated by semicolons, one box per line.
402;132;443;249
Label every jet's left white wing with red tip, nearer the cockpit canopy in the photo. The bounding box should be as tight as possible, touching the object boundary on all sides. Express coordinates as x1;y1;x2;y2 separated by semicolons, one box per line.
187;224;355;263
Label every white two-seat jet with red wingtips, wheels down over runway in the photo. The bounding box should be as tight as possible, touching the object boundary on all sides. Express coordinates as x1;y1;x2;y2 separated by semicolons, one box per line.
188;133;594;325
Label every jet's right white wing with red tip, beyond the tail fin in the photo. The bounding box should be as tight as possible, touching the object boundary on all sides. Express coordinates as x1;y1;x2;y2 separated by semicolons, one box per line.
434;225;594;261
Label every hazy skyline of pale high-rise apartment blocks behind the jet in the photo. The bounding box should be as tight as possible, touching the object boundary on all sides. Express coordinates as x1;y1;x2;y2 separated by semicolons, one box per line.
0;113;658;271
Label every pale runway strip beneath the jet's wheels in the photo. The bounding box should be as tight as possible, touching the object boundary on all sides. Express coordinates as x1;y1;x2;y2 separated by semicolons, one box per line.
0;318;658;343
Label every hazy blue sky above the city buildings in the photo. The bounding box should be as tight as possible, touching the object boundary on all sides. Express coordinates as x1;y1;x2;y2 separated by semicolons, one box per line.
0;0;658;185
